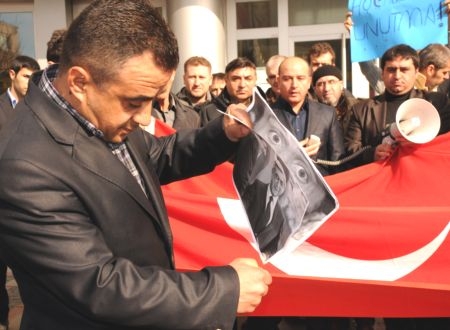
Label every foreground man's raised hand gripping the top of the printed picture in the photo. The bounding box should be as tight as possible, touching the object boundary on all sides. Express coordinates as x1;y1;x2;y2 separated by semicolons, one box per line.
223;104;253;142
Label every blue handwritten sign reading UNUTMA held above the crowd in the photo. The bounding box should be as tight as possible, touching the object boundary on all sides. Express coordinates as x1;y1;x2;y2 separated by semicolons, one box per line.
348;0;448;62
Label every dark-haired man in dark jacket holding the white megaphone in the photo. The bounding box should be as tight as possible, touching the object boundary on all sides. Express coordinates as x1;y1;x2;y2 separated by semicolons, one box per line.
344;44;450;166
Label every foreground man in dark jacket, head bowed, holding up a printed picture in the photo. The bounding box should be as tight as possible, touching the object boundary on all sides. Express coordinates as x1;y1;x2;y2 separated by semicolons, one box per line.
0;0;271;330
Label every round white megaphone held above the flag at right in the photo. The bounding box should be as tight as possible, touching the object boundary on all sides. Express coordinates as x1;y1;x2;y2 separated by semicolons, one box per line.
383;98;441;144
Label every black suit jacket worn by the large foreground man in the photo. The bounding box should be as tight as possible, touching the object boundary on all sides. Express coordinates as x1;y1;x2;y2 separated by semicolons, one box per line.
0;76;239;330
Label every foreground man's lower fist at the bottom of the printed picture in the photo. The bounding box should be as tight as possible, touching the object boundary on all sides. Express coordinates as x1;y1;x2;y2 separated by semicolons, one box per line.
230;258;272;313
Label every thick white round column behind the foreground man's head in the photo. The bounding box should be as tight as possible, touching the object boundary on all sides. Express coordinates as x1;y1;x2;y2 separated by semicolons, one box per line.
167;0;227;93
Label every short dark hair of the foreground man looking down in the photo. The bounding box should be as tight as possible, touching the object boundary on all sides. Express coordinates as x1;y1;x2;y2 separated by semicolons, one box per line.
60;0;179;84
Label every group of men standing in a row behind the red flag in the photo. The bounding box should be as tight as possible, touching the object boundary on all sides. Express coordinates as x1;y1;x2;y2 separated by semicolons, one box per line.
143;42;450;175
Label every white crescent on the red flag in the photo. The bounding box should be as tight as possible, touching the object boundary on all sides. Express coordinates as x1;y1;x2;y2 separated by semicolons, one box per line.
217;198;450;281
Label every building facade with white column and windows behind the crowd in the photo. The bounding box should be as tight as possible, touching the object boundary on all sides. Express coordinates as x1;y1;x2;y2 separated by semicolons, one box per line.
0;0;386;97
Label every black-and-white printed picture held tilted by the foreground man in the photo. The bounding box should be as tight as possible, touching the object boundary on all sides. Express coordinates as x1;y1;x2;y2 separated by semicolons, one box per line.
233;91;338;261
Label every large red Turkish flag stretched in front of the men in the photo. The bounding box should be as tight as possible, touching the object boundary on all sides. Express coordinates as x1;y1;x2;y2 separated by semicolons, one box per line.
156;118;450;317
